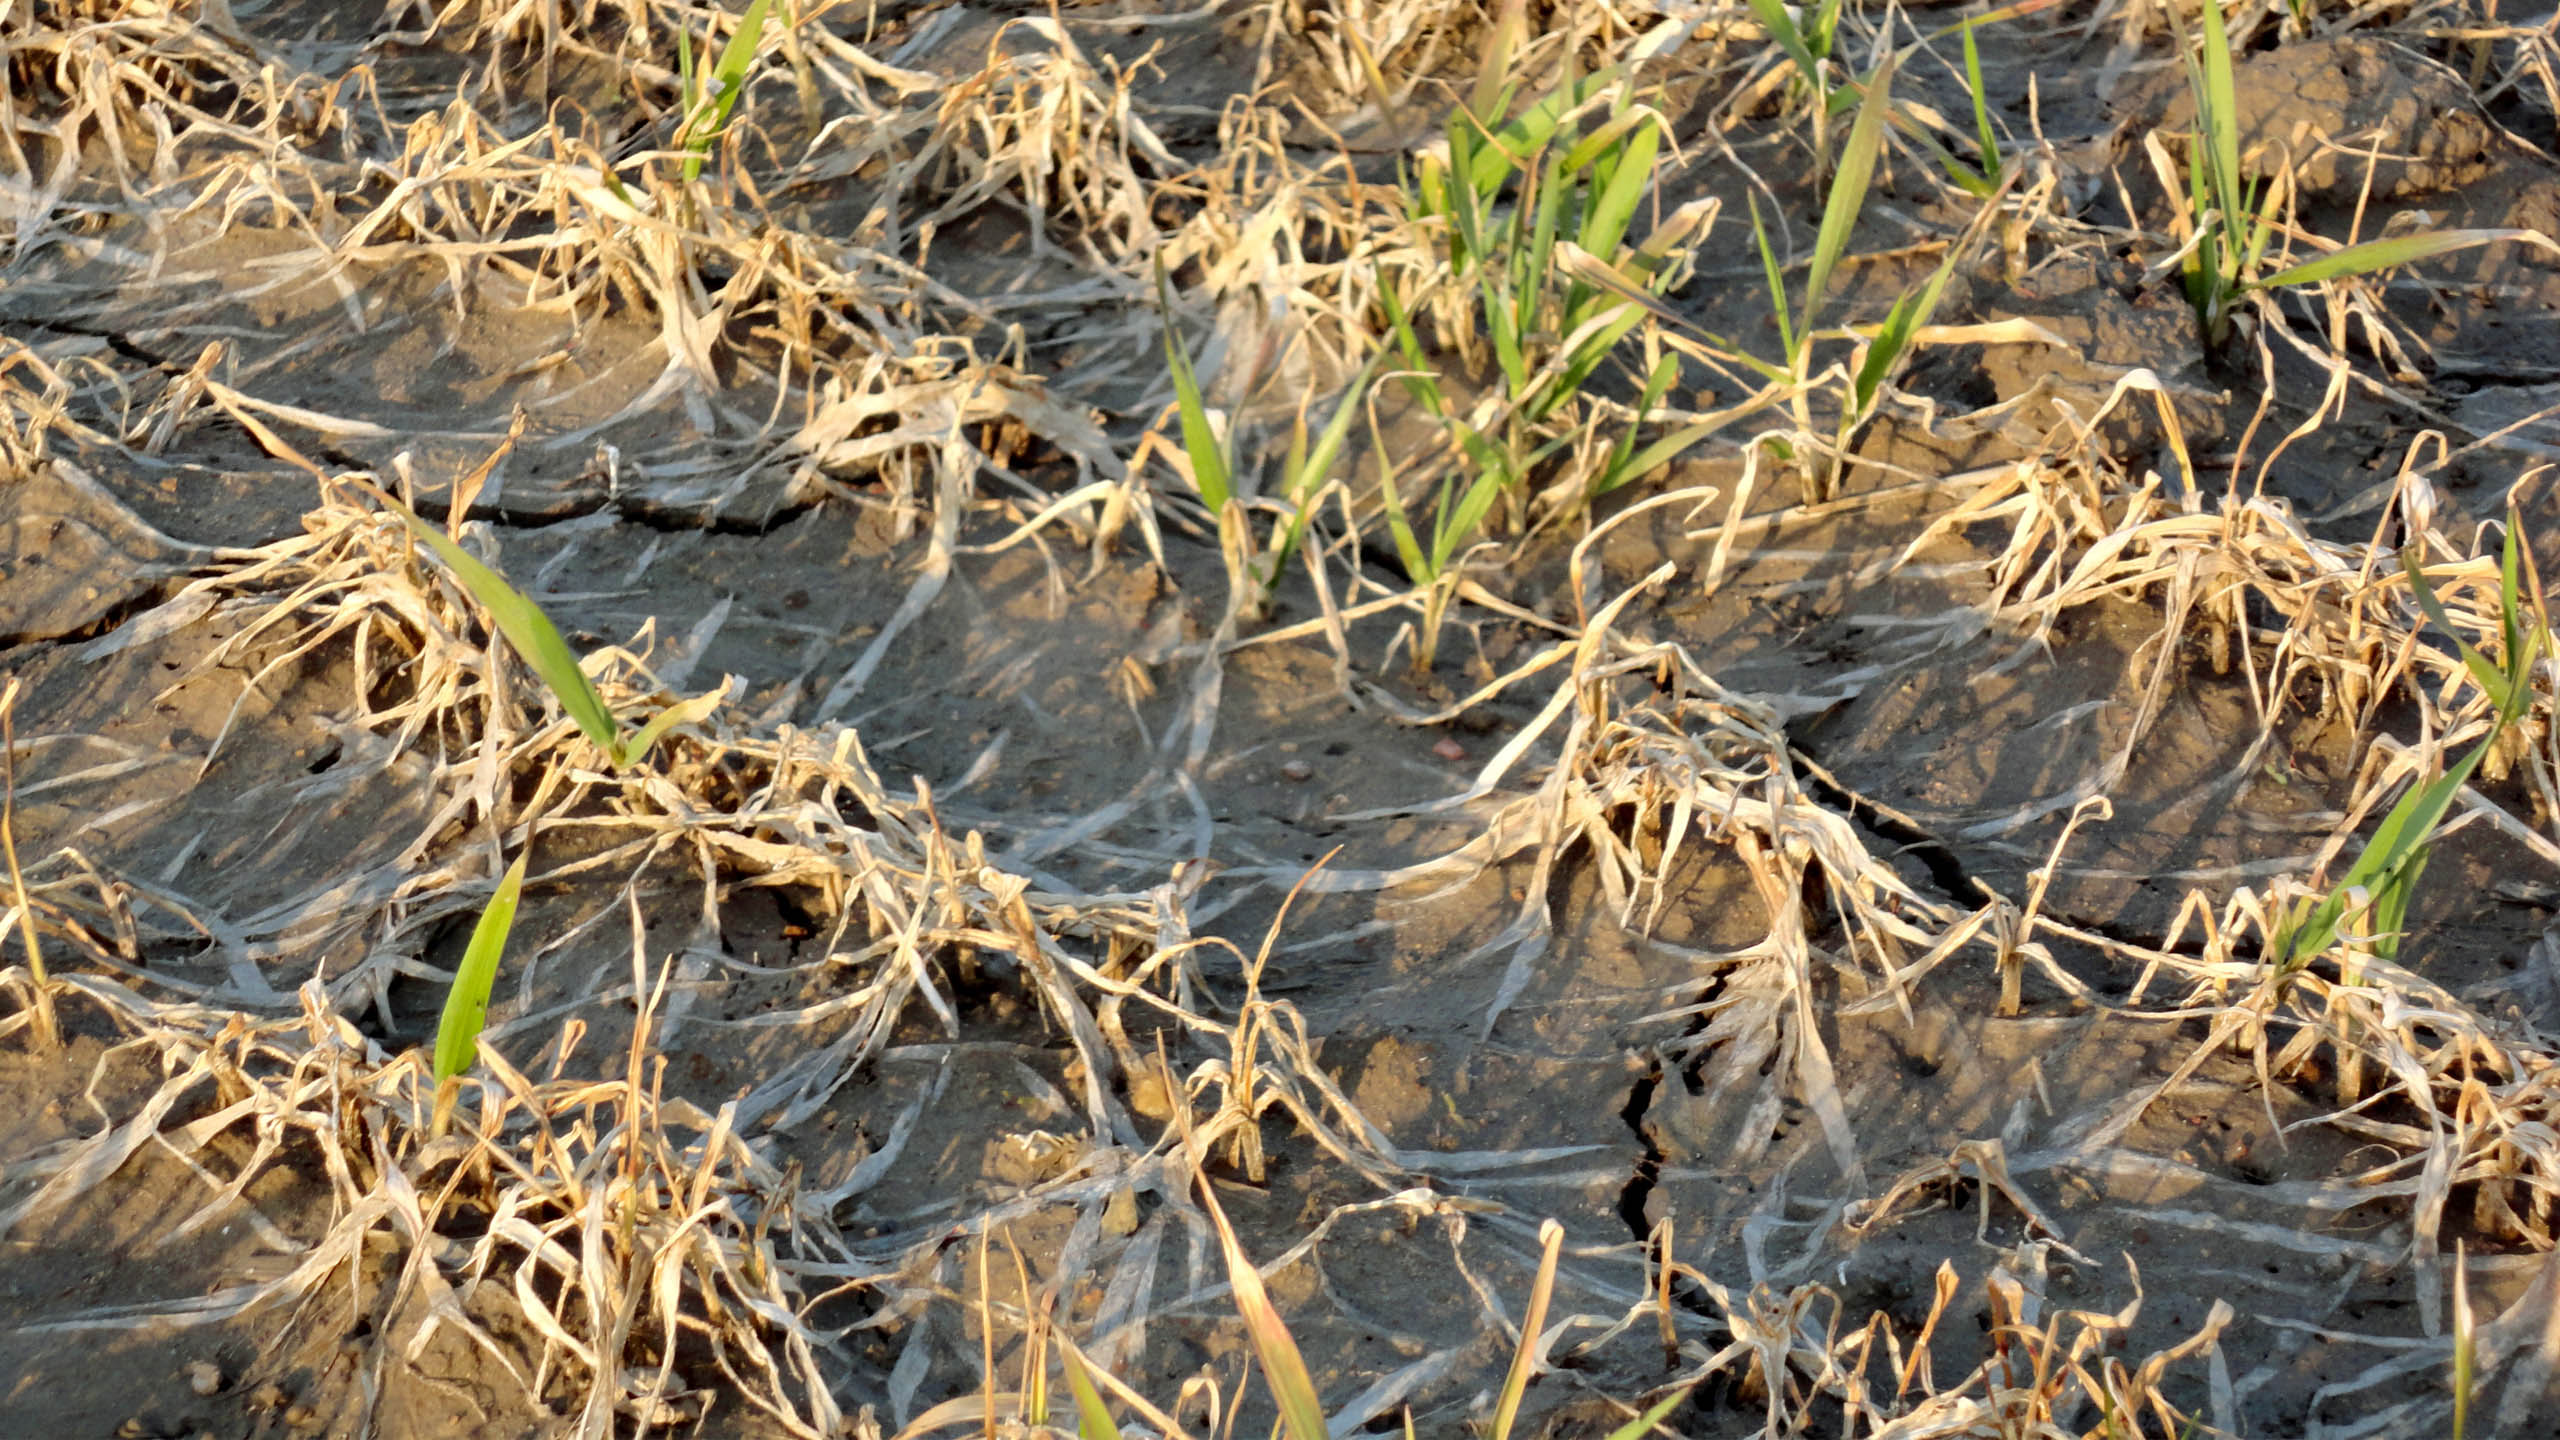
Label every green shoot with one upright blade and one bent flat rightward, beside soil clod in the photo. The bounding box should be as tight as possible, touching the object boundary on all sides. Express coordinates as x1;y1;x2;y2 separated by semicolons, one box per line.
2148;0;2550;348
